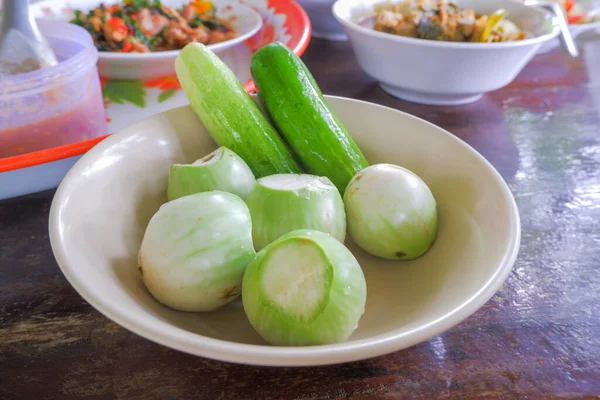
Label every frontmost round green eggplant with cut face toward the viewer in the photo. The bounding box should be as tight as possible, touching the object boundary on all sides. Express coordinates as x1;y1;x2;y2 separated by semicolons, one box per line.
242;230;367;346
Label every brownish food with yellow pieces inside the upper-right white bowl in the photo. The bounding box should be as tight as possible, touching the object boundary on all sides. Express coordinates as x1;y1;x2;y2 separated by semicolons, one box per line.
370;0;527;43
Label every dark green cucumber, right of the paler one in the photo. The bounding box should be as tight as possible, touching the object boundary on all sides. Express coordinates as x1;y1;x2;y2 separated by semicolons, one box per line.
250;42;369;193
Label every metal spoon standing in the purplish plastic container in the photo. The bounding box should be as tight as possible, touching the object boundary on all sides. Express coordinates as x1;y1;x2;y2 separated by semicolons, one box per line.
0;0;58;76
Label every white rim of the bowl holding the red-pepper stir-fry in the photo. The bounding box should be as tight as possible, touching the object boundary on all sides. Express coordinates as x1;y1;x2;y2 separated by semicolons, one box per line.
92;0;263;62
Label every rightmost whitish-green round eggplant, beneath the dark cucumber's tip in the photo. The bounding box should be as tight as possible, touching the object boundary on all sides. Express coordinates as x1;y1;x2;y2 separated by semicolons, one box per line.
344;164;438;260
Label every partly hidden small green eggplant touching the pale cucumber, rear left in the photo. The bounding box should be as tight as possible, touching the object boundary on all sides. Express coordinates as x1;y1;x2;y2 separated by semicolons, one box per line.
167;147;256;201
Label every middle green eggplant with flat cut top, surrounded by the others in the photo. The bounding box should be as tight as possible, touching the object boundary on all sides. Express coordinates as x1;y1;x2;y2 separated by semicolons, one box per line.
246;174;346;251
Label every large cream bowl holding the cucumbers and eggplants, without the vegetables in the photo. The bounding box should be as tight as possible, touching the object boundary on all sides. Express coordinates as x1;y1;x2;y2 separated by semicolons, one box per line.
50;97;520;366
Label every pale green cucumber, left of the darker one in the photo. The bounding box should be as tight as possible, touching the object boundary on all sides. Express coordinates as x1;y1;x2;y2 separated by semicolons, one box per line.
175;43;303;178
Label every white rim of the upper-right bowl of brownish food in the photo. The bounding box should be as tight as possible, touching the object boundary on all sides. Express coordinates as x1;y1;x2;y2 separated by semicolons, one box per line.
331;0;560;50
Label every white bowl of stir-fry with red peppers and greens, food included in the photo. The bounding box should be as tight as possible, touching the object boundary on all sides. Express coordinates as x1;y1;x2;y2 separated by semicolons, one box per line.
33;0;263;79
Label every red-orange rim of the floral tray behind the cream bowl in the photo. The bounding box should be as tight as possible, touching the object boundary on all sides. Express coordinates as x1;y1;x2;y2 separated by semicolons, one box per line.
0;0;312;174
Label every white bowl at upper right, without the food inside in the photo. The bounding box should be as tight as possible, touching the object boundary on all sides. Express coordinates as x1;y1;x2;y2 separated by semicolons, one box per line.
333;0;559;105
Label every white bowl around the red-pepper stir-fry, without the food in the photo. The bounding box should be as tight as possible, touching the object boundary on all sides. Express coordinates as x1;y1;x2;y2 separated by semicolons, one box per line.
31;0;262;79
